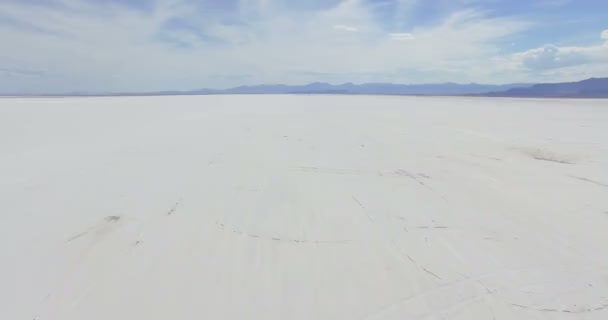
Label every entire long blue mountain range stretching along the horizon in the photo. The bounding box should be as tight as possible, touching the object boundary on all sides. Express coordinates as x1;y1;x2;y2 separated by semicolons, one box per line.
4;78;608;98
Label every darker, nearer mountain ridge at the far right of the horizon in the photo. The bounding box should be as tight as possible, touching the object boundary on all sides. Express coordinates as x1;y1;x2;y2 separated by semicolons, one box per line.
481;78;608;98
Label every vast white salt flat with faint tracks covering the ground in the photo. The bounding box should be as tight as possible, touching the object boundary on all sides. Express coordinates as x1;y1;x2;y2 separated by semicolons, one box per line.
0;96;608;320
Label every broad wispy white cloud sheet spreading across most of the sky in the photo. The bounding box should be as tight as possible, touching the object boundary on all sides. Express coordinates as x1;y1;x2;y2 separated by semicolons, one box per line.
0;0;608;91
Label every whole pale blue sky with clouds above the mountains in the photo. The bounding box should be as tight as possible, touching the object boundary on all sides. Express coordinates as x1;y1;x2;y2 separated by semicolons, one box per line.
0;0;608;93
